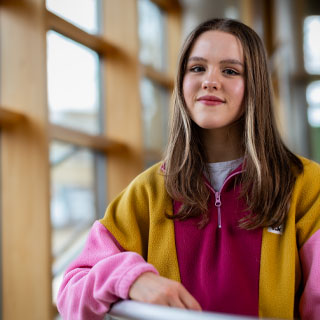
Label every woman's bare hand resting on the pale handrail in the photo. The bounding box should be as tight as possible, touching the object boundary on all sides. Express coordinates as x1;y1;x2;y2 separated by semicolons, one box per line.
129;272;201;311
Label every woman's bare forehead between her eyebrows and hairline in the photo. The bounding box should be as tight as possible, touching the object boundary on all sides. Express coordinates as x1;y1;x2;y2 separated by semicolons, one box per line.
188;30;243;62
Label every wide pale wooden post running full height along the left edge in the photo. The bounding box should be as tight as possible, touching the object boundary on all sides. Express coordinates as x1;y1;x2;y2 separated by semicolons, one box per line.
0;0;52;320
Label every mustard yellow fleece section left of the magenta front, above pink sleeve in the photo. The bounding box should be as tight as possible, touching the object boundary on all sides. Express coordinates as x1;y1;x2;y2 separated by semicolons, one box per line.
100;163;180;281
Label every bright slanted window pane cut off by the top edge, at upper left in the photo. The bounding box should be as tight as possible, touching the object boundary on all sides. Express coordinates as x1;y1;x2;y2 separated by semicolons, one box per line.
46;0;99;33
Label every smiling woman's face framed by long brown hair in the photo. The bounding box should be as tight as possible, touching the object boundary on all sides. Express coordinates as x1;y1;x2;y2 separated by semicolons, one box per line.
183;30;245;129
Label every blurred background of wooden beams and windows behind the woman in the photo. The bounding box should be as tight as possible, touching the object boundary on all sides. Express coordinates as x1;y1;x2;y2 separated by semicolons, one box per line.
0;0;320;320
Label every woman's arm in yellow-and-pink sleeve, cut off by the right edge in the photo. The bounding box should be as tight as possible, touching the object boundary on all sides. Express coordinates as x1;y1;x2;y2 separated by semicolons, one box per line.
294;161;320;320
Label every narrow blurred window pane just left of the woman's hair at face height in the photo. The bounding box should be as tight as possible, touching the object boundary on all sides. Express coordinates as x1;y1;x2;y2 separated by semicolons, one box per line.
140;78;169;153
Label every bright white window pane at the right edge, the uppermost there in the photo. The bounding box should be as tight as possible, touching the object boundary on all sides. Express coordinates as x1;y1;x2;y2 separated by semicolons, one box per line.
303;16;320;74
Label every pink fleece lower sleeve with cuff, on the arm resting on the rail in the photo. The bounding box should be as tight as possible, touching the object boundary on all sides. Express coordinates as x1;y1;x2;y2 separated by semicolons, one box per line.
57;221;158;320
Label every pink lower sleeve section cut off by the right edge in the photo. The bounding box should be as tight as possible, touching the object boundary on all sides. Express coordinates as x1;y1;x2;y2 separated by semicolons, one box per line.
299;230;320;320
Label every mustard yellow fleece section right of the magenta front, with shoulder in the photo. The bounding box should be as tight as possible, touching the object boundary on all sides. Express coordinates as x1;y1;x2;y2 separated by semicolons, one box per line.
259;158;320;319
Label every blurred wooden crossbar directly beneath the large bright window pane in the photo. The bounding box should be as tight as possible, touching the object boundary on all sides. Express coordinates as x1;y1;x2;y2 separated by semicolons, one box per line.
49;124;126;153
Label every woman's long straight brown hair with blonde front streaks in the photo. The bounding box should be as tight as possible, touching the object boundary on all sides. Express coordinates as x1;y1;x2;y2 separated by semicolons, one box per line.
165;19;303;229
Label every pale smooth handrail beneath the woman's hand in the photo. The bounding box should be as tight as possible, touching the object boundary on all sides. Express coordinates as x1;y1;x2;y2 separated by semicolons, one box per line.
105;300;264;320
